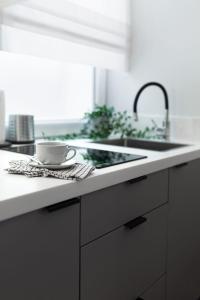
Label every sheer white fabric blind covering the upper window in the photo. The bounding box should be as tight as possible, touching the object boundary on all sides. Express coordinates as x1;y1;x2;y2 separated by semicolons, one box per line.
0;0;130;70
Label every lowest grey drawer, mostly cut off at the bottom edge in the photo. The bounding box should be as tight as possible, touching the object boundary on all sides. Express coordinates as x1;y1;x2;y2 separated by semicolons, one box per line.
139;277;166;300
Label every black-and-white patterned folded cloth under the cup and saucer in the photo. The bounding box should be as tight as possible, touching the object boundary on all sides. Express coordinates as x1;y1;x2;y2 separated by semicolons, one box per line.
6;160;95;181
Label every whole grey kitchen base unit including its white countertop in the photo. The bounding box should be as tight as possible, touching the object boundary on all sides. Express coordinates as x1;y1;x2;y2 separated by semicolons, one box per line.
0;142;200;300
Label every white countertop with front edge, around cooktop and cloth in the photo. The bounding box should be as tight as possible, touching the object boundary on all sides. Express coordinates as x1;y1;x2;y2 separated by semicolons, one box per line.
0;141;200;221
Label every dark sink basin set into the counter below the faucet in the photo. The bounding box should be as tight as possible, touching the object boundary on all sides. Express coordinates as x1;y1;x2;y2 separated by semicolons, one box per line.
95;139;187;151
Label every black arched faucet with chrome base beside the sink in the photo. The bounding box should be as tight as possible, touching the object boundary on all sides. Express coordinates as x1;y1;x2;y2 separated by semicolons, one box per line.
133;82;170;139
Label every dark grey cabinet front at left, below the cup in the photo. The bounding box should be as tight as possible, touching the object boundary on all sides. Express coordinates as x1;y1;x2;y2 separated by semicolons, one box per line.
0;199;79;300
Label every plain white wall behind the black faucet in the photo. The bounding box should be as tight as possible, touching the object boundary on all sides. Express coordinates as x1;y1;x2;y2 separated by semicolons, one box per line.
107;0;200;139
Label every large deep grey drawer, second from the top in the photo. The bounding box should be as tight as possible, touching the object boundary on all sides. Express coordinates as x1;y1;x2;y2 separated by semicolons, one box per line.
81;205;168;300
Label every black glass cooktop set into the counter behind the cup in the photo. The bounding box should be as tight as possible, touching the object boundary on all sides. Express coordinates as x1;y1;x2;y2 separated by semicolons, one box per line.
2;144;146;169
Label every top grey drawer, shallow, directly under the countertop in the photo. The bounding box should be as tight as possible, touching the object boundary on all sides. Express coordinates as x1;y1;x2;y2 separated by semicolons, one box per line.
81;170;168;245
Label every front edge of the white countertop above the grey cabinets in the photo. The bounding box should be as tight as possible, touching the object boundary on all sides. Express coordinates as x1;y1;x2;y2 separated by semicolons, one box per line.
0;146;200;221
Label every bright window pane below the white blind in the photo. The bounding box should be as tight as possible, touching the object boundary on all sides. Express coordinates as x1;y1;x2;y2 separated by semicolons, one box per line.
0;52;95;123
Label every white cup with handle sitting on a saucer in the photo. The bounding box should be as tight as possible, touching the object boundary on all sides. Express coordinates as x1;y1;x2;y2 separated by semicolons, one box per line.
36;142;77;165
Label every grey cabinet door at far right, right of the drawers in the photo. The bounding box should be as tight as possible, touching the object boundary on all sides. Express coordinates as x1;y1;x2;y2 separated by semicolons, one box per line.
167;160;200;300
